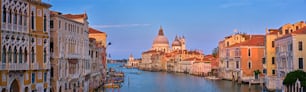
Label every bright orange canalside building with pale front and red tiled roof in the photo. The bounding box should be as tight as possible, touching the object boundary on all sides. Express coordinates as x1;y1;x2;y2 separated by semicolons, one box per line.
226;35;265;82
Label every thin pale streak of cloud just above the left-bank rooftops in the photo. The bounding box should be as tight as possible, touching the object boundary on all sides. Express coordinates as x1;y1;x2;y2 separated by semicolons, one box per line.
92;24;151;28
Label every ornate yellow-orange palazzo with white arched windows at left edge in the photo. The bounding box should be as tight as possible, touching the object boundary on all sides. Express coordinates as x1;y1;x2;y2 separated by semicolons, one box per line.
0;0;51;92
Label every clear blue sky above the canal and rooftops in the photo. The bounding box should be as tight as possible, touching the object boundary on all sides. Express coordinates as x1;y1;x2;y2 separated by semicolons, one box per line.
43;0;306;59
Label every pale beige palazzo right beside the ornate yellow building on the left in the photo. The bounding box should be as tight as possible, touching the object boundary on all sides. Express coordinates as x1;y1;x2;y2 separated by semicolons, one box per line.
50;11;92;92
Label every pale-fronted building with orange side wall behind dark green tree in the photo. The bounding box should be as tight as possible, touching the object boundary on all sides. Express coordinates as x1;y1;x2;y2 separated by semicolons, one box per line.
275;27;306;88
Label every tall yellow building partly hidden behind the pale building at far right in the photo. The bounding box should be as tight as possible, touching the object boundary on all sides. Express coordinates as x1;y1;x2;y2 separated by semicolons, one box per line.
263;21;306;90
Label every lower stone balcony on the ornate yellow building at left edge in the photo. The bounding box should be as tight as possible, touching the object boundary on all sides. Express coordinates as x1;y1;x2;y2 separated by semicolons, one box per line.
0;63;29;70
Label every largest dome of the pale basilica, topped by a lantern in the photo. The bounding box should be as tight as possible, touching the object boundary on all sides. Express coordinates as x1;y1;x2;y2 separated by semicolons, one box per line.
153;28;169;45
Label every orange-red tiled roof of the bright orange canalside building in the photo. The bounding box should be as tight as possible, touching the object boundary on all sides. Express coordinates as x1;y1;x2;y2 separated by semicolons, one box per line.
230;35;265;47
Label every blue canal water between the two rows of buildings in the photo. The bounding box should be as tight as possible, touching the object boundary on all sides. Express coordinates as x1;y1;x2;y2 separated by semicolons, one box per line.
105;64;262;92
